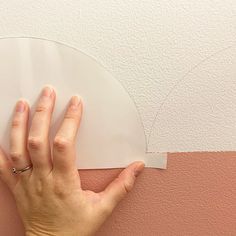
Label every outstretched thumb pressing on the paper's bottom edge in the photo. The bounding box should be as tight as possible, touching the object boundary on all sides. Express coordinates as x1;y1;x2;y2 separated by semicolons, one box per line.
100;161;144;211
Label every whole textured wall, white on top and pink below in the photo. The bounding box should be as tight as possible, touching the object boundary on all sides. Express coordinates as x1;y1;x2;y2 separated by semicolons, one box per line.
0;0;236;236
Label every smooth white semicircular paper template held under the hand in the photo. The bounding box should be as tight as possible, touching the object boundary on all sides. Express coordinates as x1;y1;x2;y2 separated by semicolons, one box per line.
0;38;166;169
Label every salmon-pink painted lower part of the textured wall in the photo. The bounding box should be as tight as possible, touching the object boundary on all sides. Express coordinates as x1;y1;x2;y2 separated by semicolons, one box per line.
0;152;236;236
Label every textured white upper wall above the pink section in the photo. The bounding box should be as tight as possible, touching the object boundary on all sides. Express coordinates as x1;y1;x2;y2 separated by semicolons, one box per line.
0;0;236;151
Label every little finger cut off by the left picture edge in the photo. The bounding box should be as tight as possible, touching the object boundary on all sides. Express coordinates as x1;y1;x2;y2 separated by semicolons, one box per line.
0;148;17;190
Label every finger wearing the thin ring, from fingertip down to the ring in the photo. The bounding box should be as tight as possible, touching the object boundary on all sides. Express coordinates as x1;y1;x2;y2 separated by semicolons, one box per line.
10;100;31;173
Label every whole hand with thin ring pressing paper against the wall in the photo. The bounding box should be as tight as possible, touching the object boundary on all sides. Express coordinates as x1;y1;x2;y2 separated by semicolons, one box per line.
0;87;144;236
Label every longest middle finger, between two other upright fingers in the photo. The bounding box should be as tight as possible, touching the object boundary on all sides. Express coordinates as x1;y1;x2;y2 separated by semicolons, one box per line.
28;86;56;174
